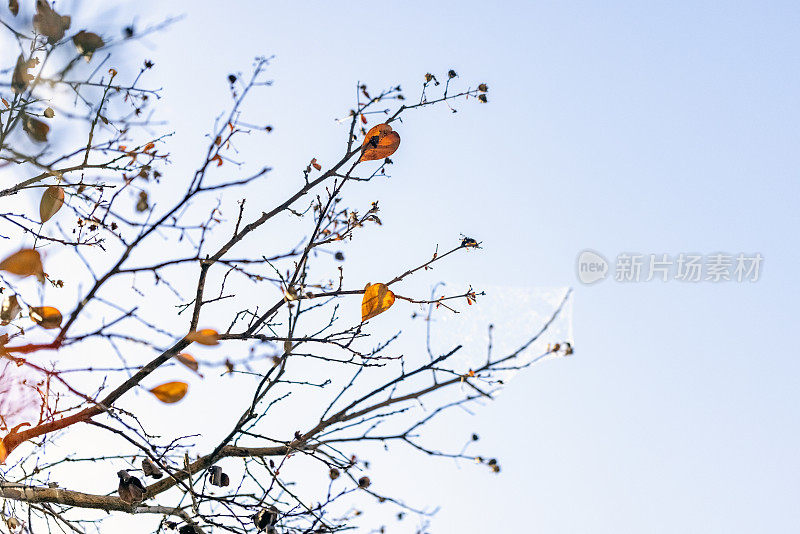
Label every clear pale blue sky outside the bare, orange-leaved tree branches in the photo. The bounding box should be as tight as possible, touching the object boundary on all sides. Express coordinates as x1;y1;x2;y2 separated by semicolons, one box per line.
12;1;800;534
